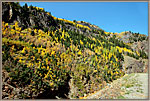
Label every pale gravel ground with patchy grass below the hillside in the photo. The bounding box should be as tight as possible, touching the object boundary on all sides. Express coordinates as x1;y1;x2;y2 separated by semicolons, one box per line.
84;73;148;99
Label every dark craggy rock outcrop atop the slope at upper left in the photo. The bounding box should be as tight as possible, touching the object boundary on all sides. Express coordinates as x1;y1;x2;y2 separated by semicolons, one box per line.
2;2;57;30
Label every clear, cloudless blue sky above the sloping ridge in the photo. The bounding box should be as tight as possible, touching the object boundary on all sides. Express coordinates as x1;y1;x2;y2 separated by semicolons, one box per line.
20;2;148;35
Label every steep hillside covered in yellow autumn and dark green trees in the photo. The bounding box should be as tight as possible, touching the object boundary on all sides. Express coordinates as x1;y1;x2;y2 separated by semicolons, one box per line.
2;2;148;99
